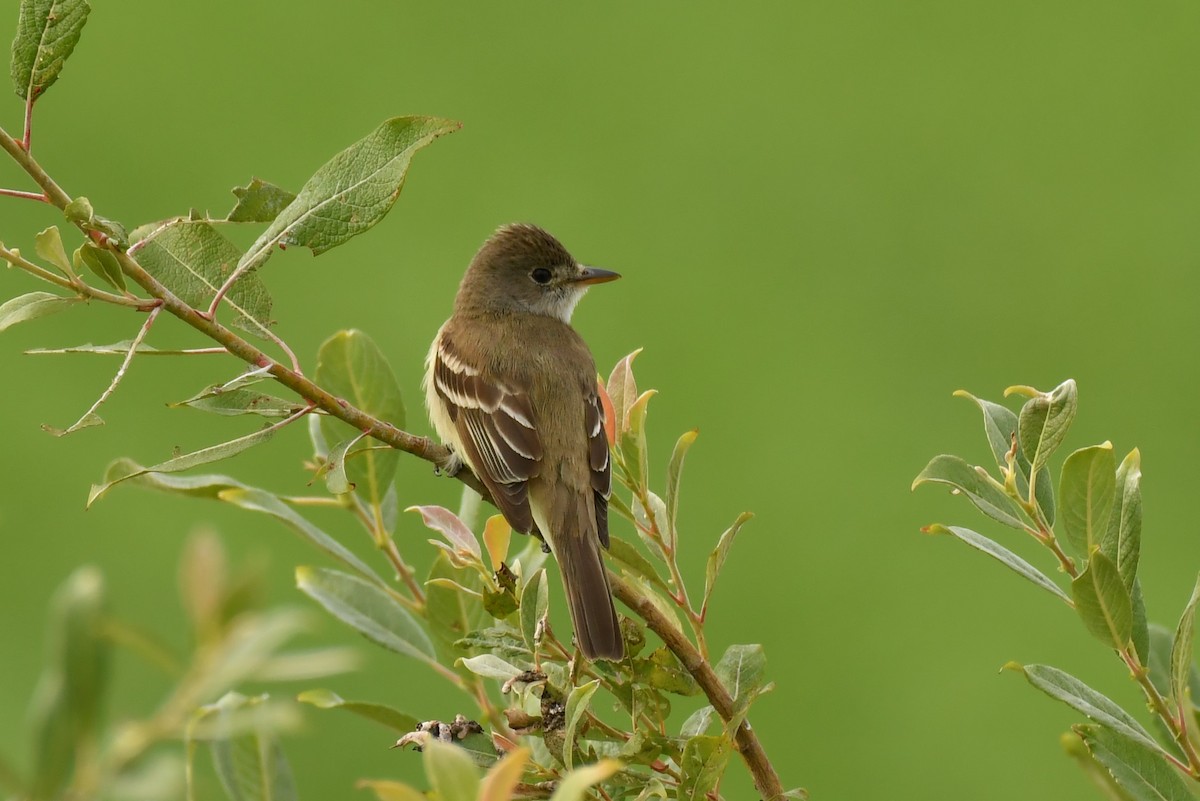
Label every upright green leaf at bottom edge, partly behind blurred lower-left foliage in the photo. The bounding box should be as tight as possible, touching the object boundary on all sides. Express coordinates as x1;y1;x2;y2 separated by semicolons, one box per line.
210;693;296;801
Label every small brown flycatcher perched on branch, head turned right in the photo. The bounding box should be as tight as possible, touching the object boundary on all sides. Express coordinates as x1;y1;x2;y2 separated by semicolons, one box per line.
424;224;624;660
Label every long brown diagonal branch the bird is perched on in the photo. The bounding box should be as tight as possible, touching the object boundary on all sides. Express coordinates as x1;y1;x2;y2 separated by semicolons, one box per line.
0;120;784;801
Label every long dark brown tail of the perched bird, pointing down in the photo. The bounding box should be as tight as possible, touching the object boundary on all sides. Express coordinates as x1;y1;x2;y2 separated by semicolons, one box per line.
539;484;625;660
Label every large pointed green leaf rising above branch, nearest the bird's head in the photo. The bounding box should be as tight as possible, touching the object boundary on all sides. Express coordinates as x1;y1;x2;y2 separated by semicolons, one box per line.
238;116;461;281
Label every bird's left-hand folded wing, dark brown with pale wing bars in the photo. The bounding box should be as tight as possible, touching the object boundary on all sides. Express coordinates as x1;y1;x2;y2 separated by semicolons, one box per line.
433;333;542;534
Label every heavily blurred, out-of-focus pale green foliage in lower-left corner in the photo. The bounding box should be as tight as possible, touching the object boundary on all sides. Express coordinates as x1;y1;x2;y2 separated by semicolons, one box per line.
0;534;358;801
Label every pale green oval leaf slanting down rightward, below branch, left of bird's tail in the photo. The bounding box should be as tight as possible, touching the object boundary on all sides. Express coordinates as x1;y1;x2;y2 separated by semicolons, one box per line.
296;567;437;663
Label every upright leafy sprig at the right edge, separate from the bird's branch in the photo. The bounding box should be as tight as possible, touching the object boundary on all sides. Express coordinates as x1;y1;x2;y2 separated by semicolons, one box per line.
913;380;1200;801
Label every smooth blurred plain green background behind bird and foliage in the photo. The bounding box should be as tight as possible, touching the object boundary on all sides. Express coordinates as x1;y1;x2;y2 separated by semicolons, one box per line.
0;0;1200;800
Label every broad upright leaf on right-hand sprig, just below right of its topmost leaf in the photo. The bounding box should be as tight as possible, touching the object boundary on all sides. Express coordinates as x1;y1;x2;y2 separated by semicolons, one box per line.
1058;442;1117;556
